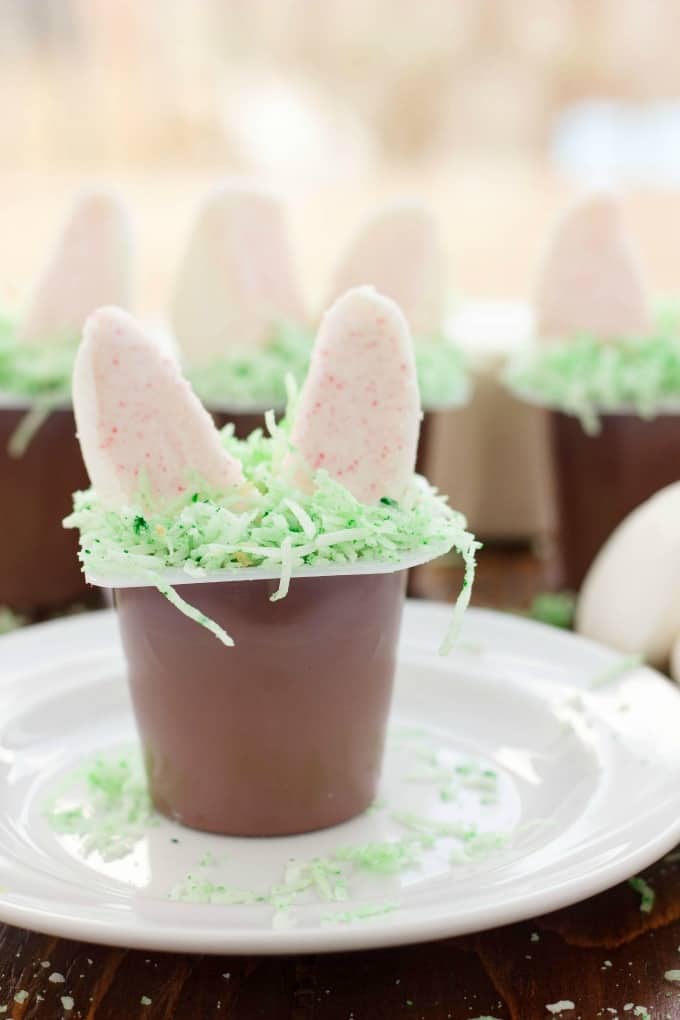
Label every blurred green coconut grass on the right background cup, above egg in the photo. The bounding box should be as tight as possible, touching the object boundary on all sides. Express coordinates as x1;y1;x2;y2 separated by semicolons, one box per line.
507;308;680;434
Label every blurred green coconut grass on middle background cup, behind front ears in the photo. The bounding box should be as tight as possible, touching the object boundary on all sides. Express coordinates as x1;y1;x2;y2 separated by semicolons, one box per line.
187;322;470;410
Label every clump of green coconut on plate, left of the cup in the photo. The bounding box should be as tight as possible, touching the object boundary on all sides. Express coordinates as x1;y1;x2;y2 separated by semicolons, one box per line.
46;755;156;861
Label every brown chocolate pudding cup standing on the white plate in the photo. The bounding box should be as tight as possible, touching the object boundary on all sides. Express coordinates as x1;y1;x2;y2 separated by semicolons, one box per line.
115;569;406;836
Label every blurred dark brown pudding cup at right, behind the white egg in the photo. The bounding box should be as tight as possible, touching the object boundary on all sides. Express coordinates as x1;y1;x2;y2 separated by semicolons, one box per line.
550;410;680;591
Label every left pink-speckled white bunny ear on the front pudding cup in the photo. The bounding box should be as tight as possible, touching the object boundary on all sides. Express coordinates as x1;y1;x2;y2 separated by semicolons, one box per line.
73;308;243;508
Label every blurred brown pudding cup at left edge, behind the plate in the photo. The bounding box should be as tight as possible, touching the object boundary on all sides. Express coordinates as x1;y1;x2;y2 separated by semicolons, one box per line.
0;401;101;618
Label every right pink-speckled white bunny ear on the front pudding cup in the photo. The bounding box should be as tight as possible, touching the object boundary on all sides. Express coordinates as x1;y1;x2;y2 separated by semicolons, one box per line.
292;287;420;504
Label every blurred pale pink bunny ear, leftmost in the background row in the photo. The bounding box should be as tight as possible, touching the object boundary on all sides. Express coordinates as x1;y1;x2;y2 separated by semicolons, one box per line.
16;191;133;344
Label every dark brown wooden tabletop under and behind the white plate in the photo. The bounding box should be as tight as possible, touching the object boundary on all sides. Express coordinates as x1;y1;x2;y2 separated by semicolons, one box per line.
0;548;680;1020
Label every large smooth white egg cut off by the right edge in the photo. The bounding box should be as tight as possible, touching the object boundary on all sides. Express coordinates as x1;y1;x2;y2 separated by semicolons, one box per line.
576;482;680;665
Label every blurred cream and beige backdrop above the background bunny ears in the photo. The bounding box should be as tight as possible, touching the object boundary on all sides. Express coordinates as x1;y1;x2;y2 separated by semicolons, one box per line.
0;0;680;312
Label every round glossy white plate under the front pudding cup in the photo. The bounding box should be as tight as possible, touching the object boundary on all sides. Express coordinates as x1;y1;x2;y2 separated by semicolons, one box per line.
0;603;680;953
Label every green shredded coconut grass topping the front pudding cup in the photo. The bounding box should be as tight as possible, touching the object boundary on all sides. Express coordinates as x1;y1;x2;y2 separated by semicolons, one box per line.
64;414;480;653
